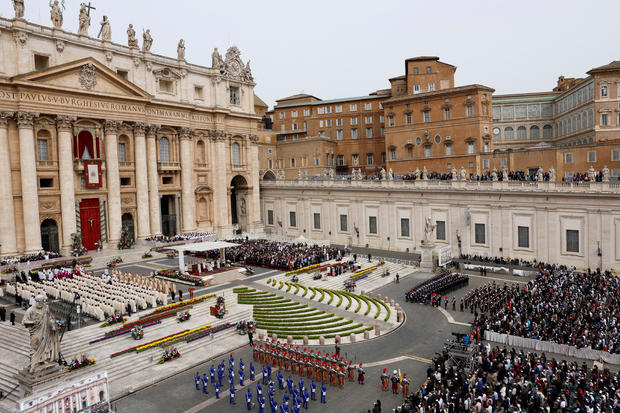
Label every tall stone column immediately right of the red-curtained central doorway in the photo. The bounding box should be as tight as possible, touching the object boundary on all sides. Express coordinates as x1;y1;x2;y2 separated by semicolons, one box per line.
104;120;122;247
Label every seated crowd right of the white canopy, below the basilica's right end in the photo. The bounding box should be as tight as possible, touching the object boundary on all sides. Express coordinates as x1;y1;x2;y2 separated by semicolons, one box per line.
207;239;346;271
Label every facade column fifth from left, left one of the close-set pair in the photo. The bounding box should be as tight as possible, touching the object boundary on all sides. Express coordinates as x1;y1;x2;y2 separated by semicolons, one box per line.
133;123;151;239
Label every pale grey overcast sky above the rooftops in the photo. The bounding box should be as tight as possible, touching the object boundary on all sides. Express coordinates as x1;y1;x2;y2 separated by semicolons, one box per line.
0;0;620;107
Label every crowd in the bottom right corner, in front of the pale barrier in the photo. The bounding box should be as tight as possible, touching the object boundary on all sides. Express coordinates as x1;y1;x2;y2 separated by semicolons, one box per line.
397;344;620;413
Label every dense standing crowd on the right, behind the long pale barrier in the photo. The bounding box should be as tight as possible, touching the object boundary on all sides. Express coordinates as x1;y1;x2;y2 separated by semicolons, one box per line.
474;266;620;354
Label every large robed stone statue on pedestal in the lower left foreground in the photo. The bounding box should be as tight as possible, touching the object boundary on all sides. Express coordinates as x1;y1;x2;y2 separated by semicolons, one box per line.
22;295;60;373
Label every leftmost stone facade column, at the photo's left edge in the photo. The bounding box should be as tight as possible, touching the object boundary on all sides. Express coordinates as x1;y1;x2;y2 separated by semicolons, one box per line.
0;112;17;255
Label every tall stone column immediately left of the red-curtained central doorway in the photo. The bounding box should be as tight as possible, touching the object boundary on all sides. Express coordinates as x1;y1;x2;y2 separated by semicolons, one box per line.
56;116;76;249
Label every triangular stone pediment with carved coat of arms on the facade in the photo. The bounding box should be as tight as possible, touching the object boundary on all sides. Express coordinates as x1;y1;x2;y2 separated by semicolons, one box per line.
12;57;151;98
